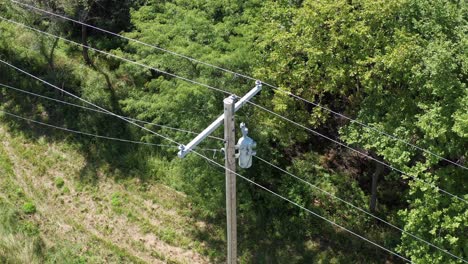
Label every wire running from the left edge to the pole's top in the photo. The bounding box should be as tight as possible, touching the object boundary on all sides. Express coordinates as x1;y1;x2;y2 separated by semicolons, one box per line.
0;16;232;95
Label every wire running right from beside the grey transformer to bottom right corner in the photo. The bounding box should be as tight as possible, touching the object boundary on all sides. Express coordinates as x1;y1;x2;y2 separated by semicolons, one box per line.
254;155;468;263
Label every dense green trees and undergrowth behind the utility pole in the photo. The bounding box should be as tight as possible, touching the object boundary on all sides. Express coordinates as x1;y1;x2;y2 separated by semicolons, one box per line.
0;0;468;263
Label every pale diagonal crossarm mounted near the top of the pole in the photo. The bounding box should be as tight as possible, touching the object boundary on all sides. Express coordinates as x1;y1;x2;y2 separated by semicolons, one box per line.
177;81;262;158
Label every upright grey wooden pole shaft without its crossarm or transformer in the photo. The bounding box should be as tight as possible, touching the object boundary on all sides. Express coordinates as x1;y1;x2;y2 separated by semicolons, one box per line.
223;96;237;264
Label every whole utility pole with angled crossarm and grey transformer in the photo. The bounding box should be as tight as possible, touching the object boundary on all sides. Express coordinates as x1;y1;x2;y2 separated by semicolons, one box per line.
177;81;262;264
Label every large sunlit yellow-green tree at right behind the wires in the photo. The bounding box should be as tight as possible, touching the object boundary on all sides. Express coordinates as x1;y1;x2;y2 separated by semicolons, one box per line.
258;0;467;263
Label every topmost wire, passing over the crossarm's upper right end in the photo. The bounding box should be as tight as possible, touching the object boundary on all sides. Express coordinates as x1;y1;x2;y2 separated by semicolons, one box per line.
12;0;468;170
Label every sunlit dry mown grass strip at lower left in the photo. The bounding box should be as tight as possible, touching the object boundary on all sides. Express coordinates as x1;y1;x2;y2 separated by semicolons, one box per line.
0;124;214;263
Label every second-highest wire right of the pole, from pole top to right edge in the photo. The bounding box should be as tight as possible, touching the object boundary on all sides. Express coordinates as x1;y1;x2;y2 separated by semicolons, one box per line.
247;101;468;203
